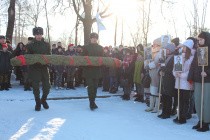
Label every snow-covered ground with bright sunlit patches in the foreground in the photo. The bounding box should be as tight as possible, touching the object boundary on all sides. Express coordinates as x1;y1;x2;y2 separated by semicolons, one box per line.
0;81;210;140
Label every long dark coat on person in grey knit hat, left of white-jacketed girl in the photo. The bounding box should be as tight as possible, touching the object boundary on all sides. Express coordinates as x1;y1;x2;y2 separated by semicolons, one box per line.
161;55;176;97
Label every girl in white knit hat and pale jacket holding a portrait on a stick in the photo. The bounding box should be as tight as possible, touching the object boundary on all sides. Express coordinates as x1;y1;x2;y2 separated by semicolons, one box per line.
173;40;194;124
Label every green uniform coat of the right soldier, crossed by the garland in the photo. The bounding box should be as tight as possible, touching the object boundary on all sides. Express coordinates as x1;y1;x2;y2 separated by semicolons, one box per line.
82;44;104;79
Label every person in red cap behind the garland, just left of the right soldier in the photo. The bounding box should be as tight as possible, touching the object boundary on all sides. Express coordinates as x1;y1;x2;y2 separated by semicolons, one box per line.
65;44;77;90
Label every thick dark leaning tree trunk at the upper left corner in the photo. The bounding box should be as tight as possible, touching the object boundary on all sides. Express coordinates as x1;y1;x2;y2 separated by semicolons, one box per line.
6;0;15;42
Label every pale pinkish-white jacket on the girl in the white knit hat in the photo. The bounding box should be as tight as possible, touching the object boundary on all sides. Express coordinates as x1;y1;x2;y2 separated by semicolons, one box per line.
173;53;194;90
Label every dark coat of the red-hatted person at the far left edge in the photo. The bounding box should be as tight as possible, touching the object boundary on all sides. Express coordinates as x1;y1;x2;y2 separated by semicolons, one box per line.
0;50;11;74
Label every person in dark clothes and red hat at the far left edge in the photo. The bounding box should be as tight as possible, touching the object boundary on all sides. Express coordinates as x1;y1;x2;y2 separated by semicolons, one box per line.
0;44;11;90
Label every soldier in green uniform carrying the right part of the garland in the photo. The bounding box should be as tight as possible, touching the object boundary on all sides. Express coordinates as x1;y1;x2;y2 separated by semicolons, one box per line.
83;33;103;110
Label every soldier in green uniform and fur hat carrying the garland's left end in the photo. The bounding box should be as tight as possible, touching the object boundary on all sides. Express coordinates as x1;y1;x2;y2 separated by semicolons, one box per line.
26;27;51;111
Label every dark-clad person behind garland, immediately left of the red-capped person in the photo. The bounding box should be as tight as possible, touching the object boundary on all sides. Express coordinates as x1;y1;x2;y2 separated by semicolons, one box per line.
54;46;64;90
